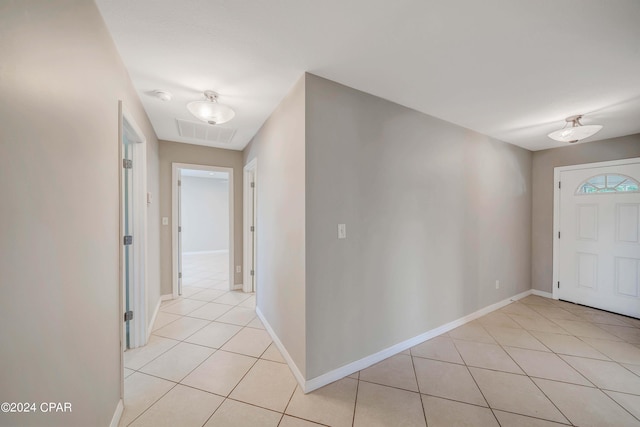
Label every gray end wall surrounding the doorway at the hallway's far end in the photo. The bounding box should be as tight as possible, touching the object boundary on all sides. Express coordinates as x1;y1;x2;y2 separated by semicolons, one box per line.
160;141;243;295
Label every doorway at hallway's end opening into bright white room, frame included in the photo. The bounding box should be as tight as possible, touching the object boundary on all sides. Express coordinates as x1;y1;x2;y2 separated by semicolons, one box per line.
172;163;234;298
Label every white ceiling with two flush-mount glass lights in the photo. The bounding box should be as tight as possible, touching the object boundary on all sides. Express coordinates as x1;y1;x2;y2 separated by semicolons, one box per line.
97;0;640;150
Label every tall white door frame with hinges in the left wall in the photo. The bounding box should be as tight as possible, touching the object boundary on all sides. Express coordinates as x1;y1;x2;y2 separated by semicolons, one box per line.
118;101;148;397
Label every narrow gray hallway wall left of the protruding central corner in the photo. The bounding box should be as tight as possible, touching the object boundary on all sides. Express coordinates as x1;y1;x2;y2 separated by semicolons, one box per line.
244;78;307;375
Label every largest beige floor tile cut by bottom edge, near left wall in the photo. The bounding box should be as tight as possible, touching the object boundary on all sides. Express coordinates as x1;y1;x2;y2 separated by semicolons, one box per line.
130;384;224;427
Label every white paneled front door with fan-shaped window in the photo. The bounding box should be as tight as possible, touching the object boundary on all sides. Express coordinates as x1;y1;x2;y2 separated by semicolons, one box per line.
555;160;640;317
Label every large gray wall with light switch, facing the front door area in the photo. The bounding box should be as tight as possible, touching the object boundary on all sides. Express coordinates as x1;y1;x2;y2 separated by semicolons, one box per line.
304;74;531;379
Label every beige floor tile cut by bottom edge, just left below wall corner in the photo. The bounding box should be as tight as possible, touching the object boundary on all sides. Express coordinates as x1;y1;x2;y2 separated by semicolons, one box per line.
204;399;282;427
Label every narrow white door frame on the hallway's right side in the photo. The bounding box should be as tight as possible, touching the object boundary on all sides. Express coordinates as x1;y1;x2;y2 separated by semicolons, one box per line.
242;158;258;292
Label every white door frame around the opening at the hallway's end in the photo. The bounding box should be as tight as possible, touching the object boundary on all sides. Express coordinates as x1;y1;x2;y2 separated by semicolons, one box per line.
171;162;235;298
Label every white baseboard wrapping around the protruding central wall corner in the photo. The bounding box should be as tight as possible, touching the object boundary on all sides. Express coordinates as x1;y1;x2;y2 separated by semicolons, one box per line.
264;290;533;393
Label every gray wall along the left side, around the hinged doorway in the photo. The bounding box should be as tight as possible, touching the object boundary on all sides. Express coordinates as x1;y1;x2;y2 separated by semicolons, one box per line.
0;0;158;426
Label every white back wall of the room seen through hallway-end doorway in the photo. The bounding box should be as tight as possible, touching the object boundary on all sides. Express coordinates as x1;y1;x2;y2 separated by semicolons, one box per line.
181;176;229;253
